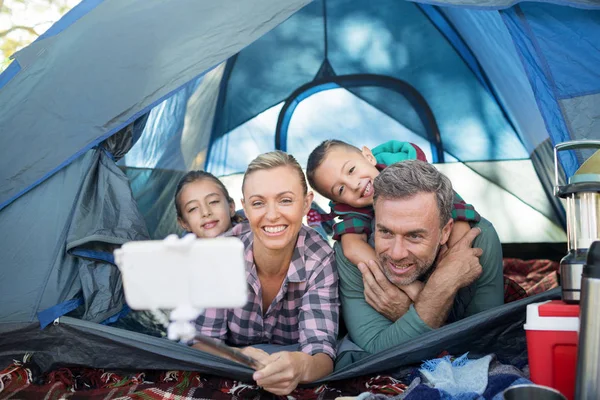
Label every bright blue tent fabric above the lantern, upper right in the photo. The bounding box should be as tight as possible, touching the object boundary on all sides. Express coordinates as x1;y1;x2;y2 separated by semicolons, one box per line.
502;4;600;176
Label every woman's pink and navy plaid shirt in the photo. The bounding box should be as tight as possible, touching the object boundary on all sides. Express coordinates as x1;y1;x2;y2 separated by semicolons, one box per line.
196;223;339;359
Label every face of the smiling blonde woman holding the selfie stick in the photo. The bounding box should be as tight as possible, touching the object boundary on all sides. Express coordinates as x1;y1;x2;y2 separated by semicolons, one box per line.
242;166;313;250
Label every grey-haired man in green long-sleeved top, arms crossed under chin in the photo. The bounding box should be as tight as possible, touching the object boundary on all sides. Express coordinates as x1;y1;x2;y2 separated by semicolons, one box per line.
335;160;504;353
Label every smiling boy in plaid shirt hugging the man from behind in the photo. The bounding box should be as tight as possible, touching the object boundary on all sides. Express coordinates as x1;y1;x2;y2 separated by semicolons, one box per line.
306;140;480;301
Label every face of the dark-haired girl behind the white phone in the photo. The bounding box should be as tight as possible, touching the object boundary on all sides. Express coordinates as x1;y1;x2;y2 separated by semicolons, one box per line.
177;179;235;238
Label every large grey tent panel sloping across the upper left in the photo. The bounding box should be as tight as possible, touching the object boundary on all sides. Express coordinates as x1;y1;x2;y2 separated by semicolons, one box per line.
0;0;309;209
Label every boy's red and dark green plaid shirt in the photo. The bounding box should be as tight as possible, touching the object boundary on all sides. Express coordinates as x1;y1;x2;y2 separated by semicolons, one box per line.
329;164;481;240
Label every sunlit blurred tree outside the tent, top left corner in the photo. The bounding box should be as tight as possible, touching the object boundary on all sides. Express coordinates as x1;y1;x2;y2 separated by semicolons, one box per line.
0;0;79;71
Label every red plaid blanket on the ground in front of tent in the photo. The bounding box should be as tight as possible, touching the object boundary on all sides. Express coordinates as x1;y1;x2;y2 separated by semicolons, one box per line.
0;357;407;400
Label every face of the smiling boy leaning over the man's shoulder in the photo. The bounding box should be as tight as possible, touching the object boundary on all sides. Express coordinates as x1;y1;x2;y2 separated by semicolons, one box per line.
315;146;379;208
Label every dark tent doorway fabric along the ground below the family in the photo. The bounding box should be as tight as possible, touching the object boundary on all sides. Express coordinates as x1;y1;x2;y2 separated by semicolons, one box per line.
0;289;560;384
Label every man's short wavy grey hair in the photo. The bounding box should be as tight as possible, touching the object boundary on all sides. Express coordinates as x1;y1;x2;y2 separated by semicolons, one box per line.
373;160;454;228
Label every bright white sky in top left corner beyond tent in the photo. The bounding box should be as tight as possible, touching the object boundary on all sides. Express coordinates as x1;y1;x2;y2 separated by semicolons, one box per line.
0;0;80;62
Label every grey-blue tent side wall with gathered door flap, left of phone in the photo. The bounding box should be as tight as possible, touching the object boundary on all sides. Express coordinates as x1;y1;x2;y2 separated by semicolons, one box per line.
0;148;148;322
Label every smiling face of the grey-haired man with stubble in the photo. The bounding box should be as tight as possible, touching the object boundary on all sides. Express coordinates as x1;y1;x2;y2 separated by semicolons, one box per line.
375;193;453;286
